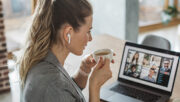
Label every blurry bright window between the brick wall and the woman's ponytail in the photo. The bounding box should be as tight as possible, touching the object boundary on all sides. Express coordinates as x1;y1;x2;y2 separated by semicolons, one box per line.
2;0;31;52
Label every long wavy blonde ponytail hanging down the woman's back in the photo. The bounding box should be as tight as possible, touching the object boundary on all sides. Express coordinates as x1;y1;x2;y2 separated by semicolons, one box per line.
19;0;52;86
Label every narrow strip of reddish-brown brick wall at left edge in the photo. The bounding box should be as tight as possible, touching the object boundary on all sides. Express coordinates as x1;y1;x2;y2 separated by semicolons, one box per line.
0;0;10;93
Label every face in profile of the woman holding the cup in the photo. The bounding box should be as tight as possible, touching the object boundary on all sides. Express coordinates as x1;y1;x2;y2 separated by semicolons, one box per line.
70;16;92;55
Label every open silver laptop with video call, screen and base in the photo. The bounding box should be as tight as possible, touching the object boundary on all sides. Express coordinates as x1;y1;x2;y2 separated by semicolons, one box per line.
100;42;180;102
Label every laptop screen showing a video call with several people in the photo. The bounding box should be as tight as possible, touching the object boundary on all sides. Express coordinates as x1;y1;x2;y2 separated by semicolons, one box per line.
119;42;179;92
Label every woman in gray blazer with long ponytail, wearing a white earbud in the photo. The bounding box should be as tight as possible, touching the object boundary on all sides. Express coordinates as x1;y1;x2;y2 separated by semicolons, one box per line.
20;0;112;102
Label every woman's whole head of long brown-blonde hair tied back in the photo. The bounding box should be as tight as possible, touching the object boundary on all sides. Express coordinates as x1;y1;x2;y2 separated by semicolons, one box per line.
19;0;92;86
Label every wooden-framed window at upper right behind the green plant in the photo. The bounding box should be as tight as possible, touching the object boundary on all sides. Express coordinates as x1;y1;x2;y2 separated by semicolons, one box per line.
139;0;180;33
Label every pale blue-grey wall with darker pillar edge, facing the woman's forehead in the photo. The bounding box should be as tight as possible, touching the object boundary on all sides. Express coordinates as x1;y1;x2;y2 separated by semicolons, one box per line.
90;0;139;42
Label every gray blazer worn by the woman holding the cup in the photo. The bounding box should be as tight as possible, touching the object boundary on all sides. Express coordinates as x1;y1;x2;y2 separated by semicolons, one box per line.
22;51;85;102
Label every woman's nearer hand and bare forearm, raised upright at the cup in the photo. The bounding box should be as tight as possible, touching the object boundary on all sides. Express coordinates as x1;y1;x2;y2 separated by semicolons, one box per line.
89;57;112;102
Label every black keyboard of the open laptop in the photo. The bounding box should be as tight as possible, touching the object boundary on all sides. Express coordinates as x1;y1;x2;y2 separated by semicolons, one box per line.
111;85;160;102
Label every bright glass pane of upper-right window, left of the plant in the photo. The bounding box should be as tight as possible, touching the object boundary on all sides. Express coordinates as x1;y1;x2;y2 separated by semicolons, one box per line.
139;0;163;26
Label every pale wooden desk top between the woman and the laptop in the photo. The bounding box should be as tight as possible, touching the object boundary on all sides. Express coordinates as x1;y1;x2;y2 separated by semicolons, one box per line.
67;35;180;100
